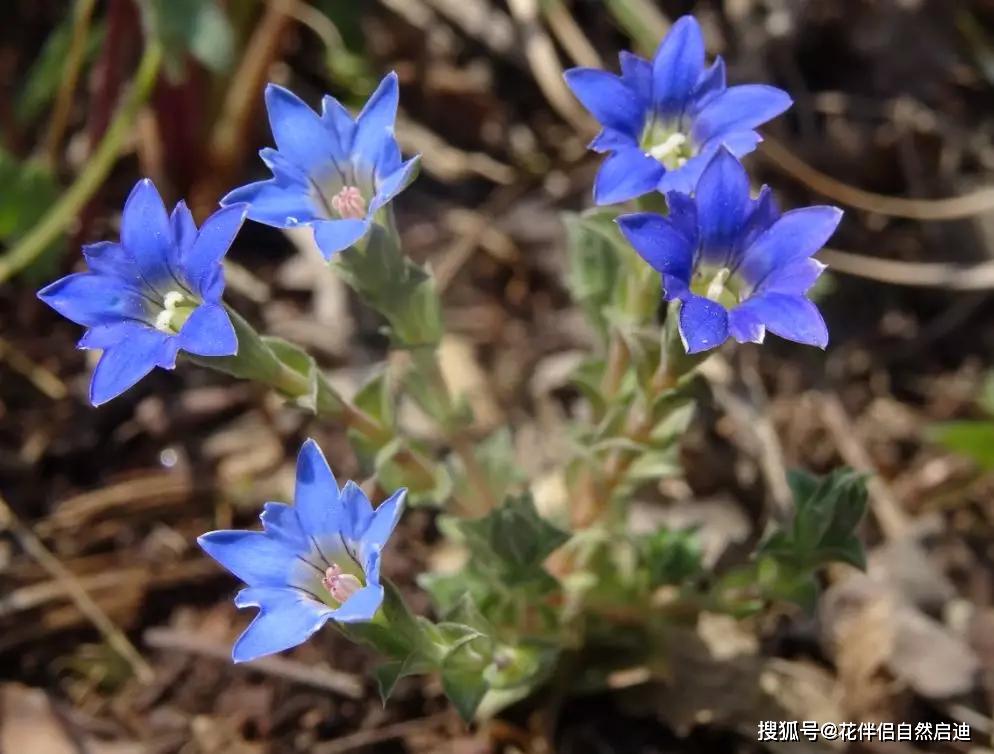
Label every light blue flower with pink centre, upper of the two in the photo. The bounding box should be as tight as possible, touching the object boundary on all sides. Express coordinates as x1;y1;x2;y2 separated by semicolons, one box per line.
221;73;419;259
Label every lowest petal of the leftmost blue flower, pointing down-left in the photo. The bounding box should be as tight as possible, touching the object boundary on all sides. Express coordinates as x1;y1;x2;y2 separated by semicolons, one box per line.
90;327;176;406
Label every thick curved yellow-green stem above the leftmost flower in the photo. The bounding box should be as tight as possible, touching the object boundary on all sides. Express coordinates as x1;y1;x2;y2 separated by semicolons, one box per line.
0;42;162;283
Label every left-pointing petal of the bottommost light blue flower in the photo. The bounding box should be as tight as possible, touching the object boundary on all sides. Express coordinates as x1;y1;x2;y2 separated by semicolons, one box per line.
197;529;299;587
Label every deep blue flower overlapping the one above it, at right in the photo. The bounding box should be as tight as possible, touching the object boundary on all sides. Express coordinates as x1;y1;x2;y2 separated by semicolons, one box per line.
618;149;842;353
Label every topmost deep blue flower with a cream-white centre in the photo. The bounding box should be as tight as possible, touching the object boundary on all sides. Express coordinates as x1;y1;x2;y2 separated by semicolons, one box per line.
566;16;791;204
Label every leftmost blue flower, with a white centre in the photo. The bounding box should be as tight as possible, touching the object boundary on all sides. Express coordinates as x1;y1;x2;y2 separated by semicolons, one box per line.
38;178;245;406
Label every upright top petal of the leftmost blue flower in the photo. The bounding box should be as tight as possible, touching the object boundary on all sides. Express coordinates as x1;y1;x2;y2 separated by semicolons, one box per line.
121;178;177;293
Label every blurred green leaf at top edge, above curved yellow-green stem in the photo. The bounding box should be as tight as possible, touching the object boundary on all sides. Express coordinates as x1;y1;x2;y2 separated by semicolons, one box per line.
139;0;235;79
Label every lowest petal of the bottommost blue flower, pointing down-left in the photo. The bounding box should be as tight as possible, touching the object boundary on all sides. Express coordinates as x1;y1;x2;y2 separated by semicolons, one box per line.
231;587;332;662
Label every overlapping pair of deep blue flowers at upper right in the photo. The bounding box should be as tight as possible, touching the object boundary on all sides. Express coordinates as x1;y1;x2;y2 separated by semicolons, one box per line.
566;16;842;354
